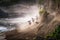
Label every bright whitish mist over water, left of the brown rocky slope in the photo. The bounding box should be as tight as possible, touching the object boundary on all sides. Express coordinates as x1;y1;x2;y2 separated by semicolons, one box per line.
0;4;39;30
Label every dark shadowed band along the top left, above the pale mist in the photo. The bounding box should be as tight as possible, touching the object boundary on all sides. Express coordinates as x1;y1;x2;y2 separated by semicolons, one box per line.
0;0;36;6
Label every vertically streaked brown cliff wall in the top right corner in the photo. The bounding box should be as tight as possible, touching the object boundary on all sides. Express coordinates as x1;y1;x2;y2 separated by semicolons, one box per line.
44;0;60;12
